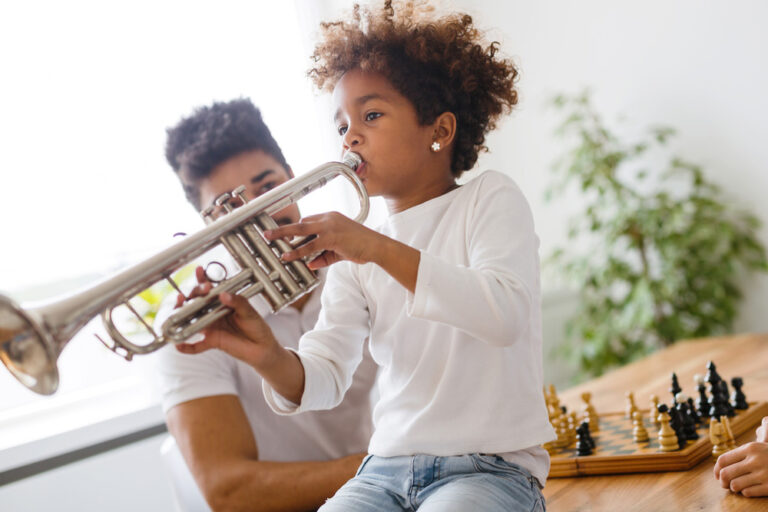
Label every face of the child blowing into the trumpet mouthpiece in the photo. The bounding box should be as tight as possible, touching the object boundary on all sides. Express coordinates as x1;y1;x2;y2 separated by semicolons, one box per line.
333;70;444;203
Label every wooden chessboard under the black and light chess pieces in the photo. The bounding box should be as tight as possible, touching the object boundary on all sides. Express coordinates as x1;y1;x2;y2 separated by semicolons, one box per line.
549;402;768;478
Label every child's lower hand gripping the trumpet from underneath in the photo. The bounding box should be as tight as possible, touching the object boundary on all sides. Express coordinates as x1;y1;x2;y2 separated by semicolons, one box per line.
176;267;281;369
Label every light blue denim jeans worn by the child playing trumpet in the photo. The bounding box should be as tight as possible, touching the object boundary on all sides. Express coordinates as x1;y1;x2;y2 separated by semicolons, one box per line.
318;454;545;512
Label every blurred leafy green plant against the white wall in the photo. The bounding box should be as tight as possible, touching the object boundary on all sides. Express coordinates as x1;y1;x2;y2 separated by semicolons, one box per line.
547;93;768;375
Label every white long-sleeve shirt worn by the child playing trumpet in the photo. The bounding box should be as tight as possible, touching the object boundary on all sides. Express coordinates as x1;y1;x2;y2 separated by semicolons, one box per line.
263;171;555;482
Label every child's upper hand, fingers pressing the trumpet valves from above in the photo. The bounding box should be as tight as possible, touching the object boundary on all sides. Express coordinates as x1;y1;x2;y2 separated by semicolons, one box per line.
264;212;388;270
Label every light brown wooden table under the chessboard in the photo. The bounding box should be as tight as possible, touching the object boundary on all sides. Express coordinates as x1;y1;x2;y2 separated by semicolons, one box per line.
544;334;768;512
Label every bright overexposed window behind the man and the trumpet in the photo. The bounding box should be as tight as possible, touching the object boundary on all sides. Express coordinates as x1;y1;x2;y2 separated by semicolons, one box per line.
0;1;366;423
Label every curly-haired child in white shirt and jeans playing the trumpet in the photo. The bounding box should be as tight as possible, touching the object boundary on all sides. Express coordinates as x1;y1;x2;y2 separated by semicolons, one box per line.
180;2;554;512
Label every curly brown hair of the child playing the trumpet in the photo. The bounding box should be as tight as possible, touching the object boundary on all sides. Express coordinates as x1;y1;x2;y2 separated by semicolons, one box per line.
308;0;518;177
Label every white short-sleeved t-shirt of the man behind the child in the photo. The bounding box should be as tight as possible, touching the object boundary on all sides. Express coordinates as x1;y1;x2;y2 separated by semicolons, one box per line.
157;272;376;462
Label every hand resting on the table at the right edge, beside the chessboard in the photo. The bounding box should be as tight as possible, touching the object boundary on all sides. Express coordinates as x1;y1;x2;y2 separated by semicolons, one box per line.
715;440;768;498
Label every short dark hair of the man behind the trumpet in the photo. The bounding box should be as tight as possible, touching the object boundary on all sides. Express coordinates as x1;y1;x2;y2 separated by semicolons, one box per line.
165;98;288;210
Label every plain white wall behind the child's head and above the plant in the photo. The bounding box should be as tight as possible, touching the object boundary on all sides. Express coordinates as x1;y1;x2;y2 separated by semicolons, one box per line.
440;0;768;332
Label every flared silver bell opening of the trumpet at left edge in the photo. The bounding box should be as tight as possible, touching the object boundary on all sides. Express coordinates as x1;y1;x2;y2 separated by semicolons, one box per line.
0;295;59;395
